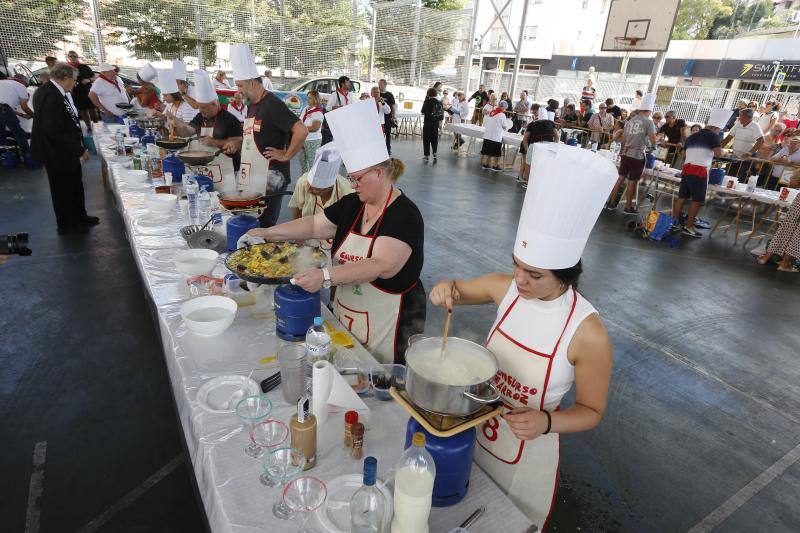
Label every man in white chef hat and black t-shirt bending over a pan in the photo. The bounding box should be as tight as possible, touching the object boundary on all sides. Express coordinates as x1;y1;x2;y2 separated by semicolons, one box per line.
172;69;242;183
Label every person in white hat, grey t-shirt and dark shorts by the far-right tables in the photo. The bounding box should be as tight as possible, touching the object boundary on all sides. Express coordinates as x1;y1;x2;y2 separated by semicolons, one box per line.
606;93;656;215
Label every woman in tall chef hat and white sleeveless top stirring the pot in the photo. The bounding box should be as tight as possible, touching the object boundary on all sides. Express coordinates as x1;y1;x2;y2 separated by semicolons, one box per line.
430;143;616;529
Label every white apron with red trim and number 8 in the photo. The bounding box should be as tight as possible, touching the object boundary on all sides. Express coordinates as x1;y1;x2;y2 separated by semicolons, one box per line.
475;288;577;530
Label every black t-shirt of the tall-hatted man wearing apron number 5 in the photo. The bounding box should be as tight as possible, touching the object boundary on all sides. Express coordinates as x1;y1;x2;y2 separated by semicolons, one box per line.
247;92;300;179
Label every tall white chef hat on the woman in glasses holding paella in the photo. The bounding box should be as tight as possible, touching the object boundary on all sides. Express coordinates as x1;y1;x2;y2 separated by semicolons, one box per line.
325;98;389;172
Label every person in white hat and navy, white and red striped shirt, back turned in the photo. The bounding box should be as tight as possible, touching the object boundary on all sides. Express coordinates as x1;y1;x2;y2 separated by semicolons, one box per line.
672;109;731;238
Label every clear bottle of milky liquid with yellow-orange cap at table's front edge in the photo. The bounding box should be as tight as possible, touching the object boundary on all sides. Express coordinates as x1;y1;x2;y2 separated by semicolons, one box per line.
392;432;436;533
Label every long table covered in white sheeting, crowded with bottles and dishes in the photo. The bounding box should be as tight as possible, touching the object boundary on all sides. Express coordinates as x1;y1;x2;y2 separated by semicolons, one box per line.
95;127;530;533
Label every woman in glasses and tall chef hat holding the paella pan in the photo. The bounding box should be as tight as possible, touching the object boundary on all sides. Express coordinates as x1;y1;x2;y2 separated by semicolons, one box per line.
248;99;425;363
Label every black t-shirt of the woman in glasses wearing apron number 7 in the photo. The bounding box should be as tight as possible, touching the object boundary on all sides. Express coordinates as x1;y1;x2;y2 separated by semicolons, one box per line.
325;193;425;292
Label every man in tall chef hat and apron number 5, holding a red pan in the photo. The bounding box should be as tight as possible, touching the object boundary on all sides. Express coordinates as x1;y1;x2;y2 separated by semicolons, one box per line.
225;44;308;227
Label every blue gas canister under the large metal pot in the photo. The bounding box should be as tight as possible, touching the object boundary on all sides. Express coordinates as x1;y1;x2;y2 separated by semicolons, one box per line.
406;416;476;507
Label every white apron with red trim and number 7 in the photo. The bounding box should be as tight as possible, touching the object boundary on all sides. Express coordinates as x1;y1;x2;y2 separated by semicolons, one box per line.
332;194;416;363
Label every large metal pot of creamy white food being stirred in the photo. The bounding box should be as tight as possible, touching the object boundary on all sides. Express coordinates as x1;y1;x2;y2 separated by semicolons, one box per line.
406;337;500;416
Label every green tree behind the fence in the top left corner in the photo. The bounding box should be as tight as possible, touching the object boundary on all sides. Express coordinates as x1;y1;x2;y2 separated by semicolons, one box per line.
0;0;86;59
